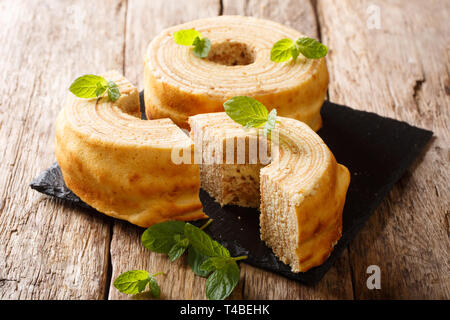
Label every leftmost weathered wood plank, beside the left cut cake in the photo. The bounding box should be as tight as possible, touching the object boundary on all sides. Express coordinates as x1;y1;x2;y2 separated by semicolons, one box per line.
0;0;125;299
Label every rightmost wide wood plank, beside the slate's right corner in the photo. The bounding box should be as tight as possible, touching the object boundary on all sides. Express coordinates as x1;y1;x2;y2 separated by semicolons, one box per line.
318;0;450;299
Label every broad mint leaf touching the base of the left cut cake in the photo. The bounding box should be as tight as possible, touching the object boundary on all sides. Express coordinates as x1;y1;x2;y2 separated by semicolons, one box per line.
141;221;186;253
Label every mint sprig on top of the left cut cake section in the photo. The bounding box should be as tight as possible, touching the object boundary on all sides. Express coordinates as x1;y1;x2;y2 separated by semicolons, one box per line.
69;74;120;101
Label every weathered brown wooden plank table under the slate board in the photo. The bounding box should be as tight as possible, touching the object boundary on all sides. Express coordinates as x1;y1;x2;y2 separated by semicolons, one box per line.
0;0;450;299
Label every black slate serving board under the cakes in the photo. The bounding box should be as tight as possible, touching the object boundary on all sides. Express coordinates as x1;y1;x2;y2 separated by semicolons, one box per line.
30;94;433;285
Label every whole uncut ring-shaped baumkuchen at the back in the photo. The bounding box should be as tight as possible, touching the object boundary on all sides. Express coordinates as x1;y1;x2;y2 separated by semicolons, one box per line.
144;16;328;131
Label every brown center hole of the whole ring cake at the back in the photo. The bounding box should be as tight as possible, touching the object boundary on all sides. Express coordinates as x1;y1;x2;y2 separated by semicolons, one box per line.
206;41;255;66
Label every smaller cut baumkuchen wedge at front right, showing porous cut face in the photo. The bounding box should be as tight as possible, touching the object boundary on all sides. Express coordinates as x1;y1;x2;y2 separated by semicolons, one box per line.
189;112;350;272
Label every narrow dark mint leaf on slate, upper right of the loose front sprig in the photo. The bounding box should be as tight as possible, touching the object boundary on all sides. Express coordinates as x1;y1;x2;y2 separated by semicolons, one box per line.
184;223;230;257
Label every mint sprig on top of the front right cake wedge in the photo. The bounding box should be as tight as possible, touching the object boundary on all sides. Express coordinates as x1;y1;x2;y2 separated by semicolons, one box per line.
223;96;277;135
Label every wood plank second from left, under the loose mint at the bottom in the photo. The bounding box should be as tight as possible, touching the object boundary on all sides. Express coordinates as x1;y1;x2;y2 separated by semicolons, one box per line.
109;0;220;299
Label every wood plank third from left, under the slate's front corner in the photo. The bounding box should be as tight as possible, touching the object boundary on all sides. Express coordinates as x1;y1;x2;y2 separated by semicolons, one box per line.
223;0;353;299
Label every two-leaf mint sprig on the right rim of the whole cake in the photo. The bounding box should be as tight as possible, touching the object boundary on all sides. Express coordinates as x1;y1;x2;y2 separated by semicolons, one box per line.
270;37;328;62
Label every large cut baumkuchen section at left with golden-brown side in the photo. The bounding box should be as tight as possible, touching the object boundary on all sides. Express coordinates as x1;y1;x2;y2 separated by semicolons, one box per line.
55;72;206;227
